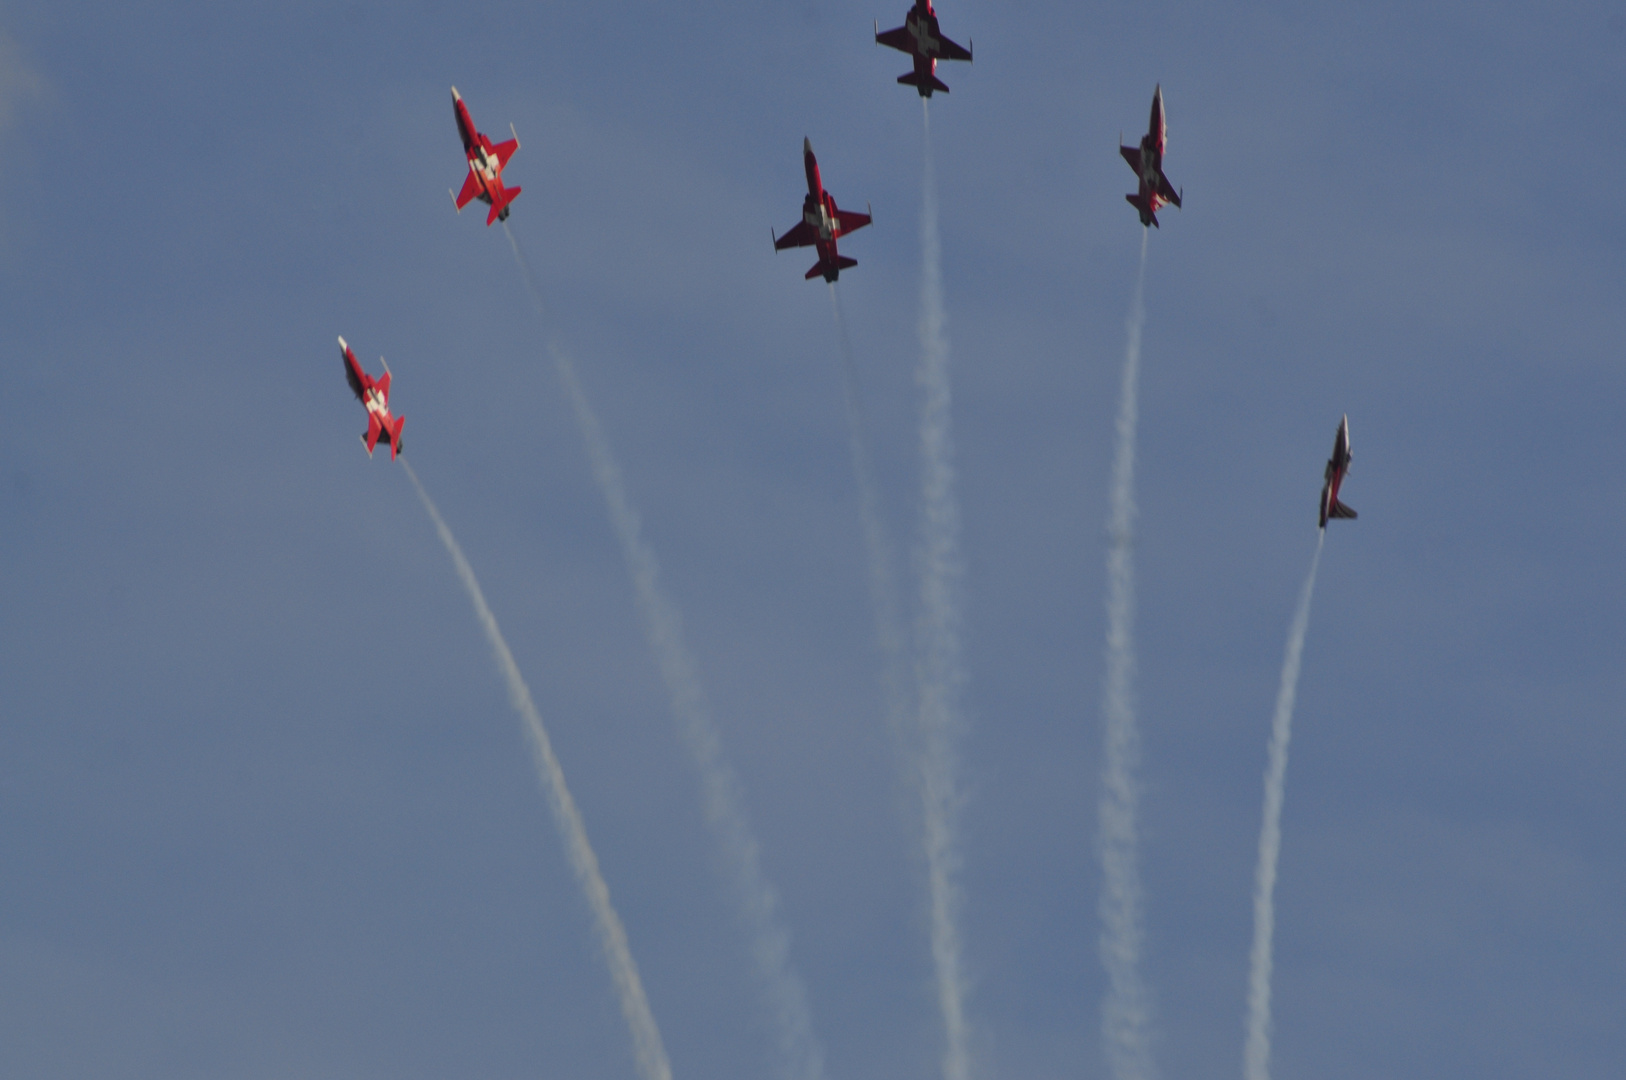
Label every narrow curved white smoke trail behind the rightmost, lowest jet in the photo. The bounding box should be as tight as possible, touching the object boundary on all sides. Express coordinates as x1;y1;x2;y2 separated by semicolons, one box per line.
1242;530;1327;1080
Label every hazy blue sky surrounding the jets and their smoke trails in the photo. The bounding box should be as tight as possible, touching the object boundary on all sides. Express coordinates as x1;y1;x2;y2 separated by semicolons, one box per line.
0;2;1626;1080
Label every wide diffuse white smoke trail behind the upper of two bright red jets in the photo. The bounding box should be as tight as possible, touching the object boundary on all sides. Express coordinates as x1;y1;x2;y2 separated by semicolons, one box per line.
502;223;824;1080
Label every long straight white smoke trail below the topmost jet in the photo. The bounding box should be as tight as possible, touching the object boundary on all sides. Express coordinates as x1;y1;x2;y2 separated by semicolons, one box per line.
915;98;971;1080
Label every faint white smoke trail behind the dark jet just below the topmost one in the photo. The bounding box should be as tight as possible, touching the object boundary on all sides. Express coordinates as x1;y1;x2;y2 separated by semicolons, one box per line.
829;281;915;748
